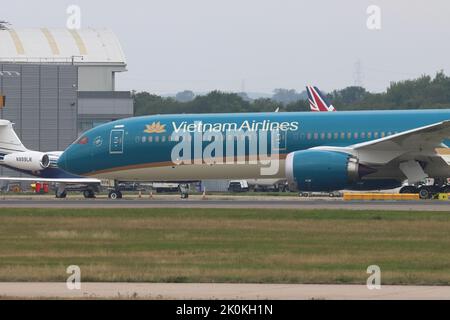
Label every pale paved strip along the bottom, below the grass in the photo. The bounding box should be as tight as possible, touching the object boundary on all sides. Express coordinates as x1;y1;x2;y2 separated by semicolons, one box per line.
0;282;450;300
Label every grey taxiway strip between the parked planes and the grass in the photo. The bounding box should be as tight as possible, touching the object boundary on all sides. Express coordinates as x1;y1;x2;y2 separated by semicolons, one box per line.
0;197;450;211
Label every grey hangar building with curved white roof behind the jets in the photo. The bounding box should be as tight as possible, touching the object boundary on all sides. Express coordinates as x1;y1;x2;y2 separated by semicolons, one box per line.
0;28;133;176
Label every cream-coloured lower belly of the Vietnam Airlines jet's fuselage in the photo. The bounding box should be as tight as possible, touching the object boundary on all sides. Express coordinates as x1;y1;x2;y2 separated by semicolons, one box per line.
92;160;285;181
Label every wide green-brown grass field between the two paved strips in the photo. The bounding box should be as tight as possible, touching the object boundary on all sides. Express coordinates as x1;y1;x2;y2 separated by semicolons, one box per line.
0;209;450;285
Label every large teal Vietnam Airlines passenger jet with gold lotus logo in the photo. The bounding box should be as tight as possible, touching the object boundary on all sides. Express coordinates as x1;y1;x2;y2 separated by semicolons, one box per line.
58;109;450;199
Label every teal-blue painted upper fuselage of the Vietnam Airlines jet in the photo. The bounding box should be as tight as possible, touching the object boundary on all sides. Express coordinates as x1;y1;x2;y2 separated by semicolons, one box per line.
59;110;450;175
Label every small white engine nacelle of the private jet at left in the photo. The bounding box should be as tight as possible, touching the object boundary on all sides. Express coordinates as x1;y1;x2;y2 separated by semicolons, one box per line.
3;151;50;171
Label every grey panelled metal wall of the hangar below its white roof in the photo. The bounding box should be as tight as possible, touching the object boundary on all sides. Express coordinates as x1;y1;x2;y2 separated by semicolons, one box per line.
0;64;78;176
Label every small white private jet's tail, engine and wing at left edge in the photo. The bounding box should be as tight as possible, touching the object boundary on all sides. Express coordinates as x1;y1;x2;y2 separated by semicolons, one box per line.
0;120;101;198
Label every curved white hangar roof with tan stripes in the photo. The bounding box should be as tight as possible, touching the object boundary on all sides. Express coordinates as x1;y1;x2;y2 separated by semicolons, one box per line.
0;28;126;65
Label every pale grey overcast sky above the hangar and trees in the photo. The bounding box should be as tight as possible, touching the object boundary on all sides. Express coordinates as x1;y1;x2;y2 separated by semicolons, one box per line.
0;0;450;94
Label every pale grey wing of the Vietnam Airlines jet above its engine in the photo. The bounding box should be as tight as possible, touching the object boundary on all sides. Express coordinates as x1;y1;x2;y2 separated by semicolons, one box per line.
313;120;450;165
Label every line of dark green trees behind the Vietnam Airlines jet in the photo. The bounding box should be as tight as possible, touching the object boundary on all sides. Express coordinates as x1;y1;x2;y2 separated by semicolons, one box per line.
133;71;450;116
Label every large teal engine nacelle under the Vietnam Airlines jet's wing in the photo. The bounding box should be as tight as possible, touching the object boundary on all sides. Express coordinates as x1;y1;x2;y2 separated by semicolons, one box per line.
286;150;364;191
